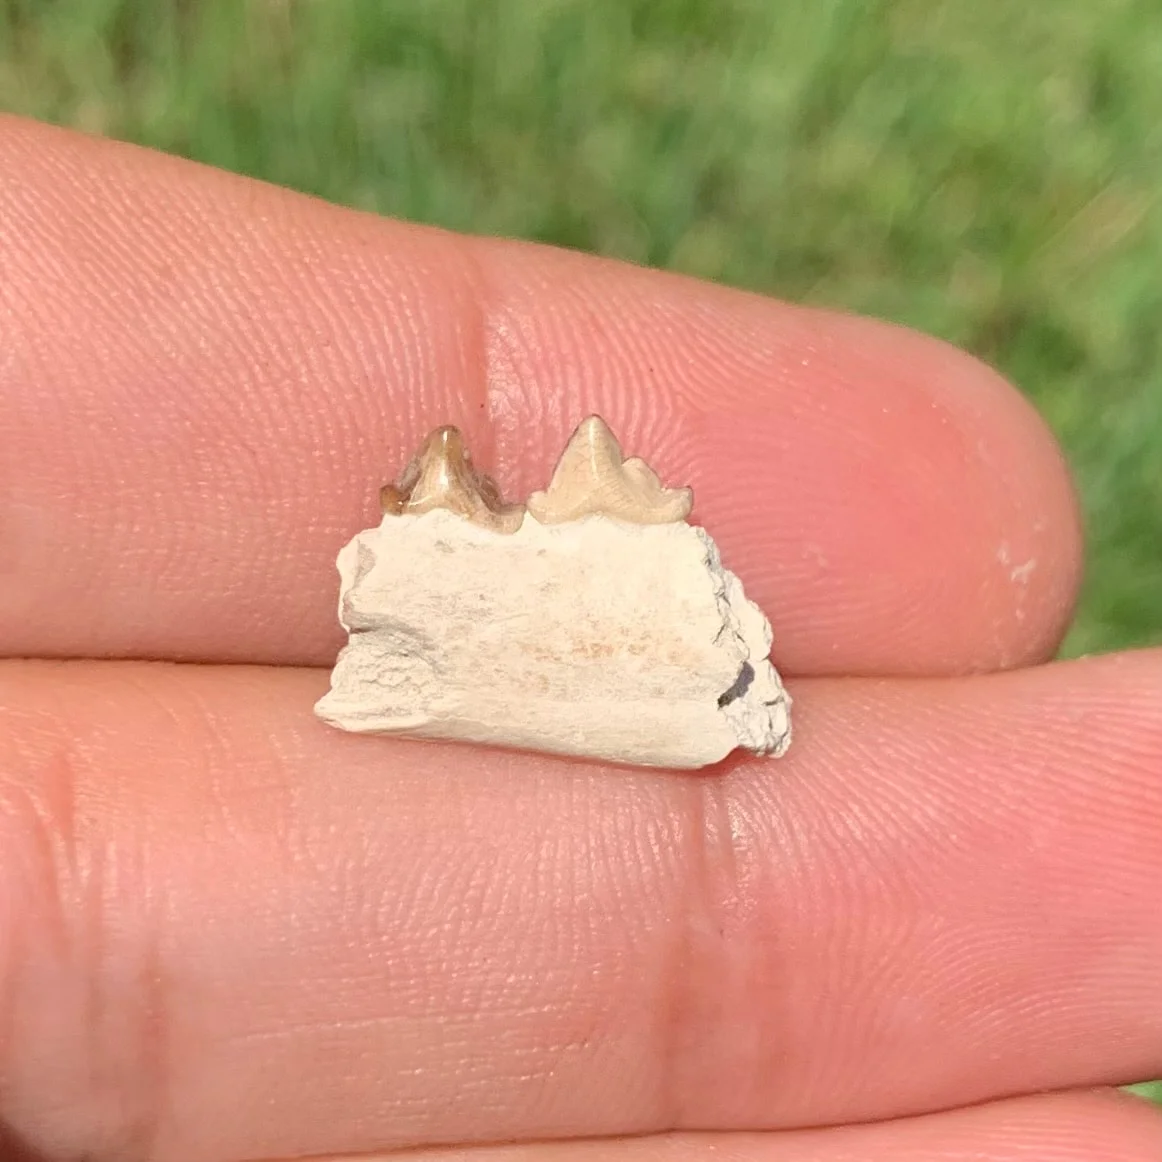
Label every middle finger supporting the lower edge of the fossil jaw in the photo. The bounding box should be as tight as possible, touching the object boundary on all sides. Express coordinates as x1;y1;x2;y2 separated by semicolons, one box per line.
0;653;1162;1157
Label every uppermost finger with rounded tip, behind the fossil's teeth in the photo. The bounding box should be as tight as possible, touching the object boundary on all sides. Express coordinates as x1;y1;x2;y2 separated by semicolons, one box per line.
0;113;1078;674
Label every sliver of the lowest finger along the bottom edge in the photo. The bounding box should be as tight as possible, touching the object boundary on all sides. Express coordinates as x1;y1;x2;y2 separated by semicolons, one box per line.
392;1093;1162;1162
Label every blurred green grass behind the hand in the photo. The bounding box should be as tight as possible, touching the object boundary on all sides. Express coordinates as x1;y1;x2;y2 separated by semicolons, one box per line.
0;0;1162;1115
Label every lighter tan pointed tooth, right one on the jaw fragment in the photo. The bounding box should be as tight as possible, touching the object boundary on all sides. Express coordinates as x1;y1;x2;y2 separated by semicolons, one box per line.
529;416;694;524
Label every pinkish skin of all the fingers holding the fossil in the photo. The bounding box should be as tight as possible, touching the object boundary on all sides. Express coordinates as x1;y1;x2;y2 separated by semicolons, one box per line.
0;120;1162;1162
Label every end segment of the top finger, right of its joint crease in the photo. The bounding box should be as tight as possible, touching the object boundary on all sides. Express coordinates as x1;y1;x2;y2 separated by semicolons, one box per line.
471;234;1081;675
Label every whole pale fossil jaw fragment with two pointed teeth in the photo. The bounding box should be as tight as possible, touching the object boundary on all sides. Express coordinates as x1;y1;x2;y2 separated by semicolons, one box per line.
315;417;791;769
